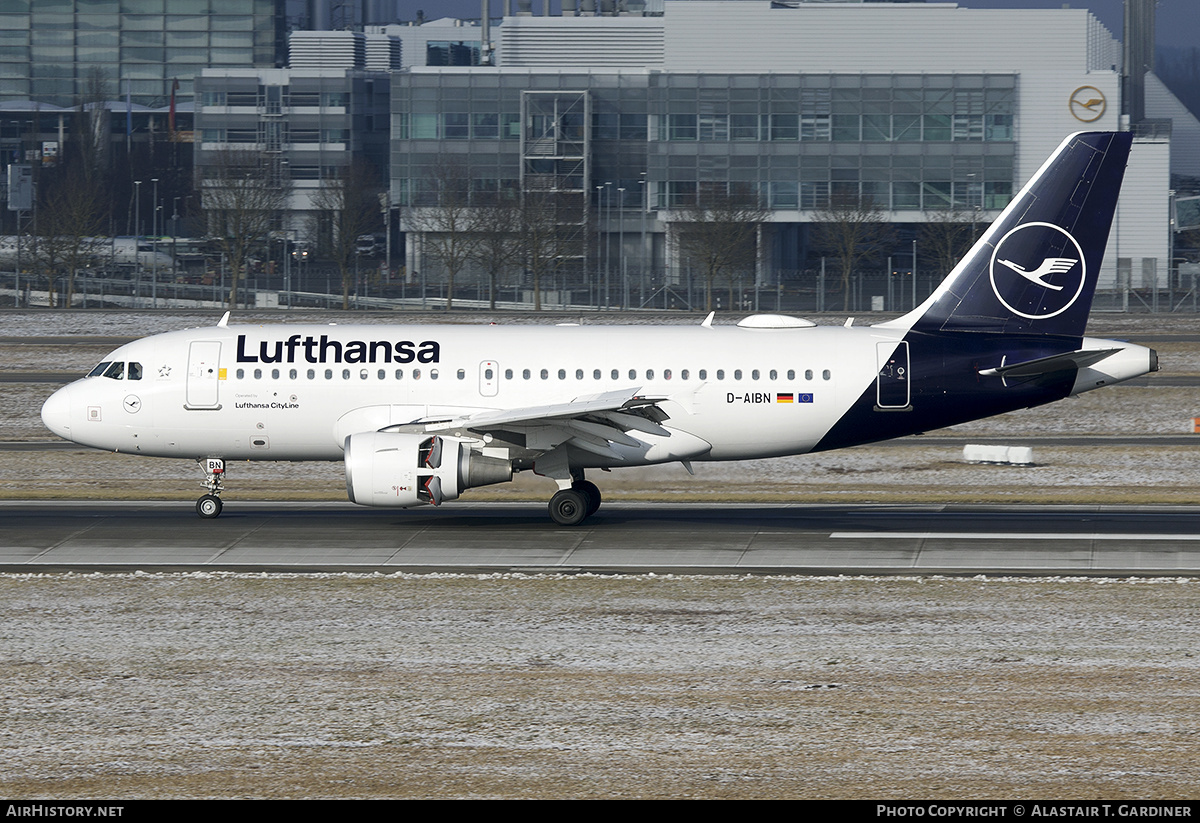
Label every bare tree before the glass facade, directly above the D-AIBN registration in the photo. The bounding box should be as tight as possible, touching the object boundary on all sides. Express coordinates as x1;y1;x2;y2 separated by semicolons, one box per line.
672;184;769;311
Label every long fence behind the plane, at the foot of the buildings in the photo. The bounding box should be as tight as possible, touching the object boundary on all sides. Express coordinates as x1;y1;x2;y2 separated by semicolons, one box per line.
0;266;1200;314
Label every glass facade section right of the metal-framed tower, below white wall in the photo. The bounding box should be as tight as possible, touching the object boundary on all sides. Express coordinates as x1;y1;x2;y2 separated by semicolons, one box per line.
648;73;1016;210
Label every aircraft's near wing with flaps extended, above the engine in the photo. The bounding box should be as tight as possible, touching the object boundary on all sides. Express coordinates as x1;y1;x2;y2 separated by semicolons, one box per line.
389;389;671;456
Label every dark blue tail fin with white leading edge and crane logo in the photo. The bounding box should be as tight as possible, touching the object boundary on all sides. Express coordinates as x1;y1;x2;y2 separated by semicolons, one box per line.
881;132;1133;337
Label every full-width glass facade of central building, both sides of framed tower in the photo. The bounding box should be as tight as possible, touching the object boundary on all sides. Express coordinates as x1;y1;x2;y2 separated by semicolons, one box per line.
391;71;1016;211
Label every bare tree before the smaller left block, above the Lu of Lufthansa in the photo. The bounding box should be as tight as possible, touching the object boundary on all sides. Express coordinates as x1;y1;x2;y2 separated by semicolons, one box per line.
198;150;290;307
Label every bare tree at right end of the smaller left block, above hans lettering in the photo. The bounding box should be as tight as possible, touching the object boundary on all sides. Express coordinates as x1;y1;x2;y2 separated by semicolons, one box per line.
312;161;383;310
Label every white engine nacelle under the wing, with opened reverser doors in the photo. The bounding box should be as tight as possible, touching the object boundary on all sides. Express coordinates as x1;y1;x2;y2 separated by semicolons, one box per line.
346;432;512;509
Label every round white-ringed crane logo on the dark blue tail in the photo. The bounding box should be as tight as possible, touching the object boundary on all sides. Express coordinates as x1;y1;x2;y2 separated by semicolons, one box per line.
990;223;1087;320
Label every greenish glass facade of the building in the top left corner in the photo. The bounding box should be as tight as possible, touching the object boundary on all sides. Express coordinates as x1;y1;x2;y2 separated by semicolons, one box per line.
0;0;284;107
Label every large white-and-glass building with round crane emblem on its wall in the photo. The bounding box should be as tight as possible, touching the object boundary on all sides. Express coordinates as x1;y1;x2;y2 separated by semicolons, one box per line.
381;0;1198;304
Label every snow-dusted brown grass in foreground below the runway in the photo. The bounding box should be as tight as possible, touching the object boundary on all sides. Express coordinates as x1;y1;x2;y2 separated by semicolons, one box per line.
0;573;1200;800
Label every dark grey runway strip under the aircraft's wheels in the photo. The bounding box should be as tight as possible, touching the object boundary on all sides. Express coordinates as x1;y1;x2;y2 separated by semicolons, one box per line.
0;500;1200;576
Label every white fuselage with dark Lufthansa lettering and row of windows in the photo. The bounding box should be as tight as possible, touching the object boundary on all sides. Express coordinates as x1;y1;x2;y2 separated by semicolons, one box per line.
43;325;904;465
